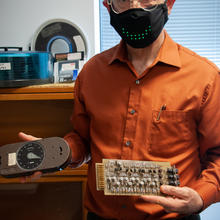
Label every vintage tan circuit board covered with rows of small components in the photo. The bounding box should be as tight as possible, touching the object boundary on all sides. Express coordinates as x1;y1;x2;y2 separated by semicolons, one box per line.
96;159;180;196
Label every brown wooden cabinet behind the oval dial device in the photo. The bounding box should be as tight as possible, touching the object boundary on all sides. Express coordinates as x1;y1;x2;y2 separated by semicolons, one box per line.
0;84;87;220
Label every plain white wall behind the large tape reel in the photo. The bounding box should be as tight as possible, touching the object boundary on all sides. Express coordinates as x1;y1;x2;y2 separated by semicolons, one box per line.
0;0;99;57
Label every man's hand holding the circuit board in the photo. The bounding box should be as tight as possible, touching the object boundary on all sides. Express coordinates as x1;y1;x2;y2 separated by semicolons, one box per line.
142;185;203;215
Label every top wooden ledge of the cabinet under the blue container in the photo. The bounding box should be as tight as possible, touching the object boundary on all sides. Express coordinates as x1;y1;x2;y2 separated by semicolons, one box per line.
0;83;74;101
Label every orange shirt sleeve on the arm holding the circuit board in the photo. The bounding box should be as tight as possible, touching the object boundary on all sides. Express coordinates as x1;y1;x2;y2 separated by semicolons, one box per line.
192;73;220;209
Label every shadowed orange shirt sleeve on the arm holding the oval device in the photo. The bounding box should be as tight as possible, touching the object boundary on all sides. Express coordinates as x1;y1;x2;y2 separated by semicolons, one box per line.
64;76;90;168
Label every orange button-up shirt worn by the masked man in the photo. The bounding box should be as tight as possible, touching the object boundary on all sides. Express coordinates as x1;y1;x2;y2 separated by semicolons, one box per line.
65;33;220;220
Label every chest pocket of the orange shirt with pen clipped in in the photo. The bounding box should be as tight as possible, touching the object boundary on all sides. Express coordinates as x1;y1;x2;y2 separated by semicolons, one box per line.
148;110;192;158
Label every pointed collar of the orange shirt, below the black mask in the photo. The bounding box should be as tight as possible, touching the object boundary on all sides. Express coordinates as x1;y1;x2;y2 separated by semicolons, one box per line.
109;31;181;68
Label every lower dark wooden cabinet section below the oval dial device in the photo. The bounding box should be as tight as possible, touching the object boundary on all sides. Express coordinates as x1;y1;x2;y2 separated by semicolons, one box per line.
0;165;87;220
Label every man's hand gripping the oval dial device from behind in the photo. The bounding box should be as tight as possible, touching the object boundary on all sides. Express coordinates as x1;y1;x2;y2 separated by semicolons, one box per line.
18;132;42;183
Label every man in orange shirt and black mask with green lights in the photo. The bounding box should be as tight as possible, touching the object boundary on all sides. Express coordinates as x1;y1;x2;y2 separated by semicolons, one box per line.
20;0;220;220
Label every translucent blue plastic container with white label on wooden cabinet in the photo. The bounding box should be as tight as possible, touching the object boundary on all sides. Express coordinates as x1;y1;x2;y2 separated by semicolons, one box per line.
0;51;53;87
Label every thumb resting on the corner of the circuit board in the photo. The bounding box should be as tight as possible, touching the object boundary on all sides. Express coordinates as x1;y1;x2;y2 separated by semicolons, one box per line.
160;185;189;199
